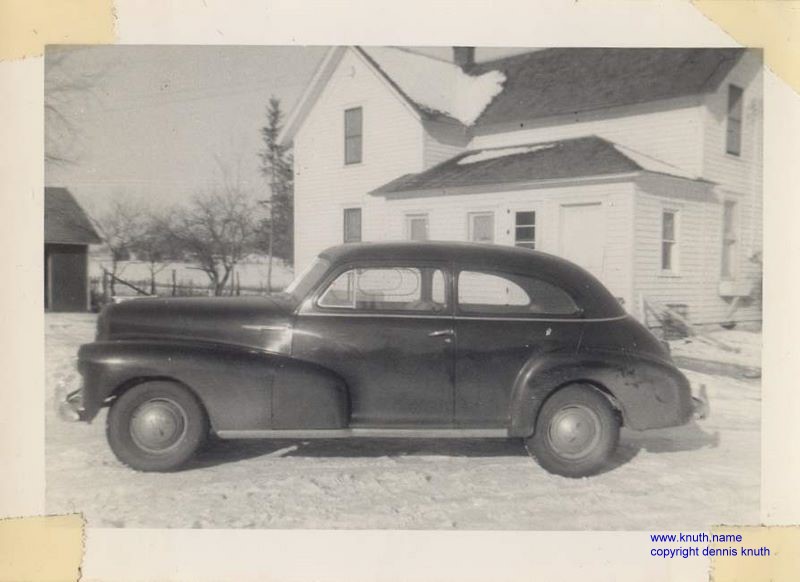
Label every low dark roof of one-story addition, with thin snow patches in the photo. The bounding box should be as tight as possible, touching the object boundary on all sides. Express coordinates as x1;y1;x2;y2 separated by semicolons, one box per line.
372;136;698;197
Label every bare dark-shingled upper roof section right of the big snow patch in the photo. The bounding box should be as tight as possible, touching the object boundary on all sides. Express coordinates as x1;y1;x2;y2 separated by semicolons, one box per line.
469;48;745;126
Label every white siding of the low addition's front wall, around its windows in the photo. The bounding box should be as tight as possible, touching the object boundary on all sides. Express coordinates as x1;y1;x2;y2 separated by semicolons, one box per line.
384;182;633;306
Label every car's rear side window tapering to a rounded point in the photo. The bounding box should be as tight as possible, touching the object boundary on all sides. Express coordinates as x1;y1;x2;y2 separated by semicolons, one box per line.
458;271;579;315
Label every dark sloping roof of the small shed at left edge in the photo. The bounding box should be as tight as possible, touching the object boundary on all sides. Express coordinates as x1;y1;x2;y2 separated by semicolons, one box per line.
44;188;102;244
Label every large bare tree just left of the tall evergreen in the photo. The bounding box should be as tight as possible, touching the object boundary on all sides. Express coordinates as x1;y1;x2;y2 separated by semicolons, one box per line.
170;164;256;295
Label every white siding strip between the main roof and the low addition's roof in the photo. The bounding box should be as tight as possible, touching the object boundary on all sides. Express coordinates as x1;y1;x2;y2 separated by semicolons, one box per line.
470;97;703;174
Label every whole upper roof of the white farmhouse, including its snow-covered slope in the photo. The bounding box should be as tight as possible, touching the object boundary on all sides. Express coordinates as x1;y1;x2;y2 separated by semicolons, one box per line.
279;47;746;144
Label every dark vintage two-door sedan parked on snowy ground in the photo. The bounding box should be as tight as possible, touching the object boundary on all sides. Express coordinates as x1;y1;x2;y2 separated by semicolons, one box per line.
62;242;706;477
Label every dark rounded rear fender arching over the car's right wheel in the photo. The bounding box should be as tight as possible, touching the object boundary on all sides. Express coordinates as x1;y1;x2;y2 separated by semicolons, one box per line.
509;350;692;437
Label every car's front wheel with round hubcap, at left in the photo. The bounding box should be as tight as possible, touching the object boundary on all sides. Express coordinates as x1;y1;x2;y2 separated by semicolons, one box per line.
106;381;209;471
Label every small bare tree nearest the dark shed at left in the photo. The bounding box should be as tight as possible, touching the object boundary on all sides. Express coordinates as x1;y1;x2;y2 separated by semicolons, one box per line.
93;197;145;295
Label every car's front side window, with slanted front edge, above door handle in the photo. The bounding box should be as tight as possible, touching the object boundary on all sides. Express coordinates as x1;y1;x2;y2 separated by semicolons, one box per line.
317;267;447;313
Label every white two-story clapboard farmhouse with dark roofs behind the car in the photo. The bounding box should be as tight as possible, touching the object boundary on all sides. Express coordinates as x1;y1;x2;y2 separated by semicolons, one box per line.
281;47;762;324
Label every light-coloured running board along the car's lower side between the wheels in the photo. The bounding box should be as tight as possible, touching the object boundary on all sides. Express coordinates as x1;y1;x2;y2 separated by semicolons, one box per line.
216;428;508;439
